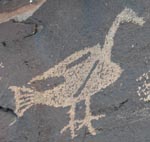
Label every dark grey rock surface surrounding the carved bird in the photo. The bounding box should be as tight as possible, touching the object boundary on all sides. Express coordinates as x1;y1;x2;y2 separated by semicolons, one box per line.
0;0;150;142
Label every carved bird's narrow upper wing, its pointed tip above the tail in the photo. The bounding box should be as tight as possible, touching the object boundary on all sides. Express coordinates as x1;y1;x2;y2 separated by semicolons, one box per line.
29;44;101;84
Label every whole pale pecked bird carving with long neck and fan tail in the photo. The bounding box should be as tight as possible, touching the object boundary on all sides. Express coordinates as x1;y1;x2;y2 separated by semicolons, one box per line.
9;8;144;138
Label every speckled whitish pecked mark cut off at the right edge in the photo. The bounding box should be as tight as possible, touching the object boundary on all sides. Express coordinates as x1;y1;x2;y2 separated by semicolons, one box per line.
136;71;150;102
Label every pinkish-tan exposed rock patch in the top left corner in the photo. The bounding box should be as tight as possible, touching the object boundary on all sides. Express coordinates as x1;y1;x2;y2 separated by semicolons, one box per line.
0;0;47;23
